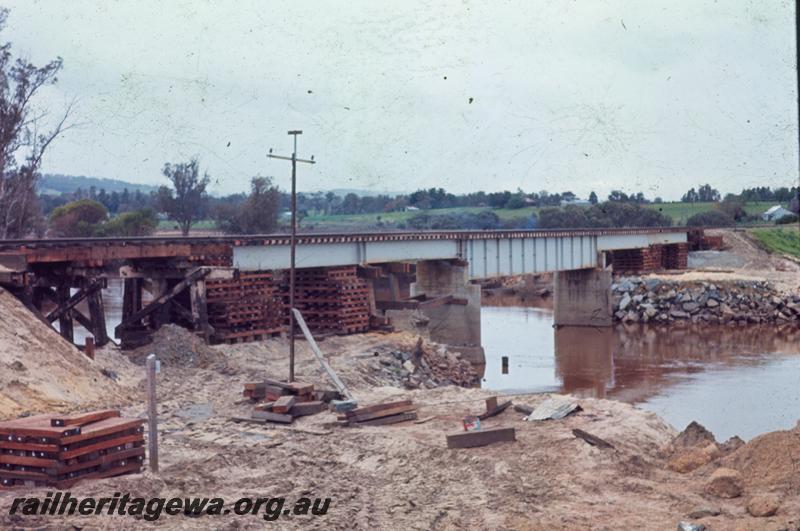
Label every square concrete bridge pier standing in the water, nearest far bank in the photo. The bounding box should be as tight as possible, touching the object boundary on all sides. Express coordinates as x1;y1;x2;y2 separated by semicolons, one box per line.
553;269;611;326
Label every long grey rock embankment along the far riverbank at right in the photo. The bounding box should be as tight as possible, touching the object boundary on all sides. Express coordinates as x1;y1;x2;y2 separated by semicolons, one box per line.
611;277;800;324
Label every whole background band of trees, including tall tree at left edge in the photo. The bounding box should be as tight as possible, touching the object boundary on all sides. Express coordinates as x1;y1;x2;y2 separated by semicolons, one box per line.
0;5;800;239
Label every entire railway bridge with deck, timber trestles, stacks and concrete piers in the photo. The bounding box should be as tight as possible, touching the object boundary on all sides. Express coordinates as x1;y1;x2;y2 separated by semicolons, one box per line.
0;227;687;368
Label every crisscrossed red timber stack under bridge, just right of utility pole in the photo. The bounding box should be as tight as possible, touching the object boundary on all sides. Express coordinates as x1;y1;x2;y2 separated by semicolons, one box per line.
287;266;371;334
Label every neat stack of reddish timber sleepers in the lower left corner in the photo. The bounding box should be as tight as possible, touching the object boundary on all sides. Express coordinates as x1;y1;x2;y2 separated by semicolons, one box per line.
0;409;145;489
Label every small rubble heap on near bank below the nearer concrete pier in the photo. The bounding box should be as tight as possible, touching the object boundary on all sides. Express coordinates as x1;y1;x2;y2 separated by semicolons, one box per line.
375;343;478;389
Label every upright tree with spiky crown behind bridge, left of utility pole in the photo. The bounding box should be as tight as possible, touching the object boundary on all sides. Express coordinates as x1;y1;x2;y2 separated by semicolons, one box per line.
158;158;211;236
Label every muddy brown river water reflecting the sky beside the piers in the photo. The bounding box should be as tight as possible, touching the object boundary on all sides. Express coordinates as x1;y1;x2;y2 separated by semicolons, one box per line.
481;305;800;440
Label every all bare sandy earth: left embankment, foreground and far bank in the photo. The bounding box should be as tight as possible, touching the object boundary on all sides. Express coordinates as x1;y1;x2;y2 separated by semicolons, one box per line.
0;228;800;530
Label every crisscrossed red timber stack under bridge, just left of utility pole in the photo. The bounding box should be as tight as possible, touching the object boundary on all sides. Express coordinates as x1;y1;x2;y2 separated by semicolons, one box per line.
206;272;286;343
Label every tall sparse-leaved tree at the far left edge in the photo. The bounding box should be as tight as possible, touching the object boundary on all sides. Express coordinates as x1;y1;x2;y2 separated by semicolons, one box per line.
0;8;71;239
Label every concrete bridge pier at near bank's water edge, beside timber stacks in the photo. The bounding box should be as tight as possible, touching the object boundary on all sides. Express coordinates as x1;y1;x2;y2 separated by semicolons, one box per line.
410;260;486;375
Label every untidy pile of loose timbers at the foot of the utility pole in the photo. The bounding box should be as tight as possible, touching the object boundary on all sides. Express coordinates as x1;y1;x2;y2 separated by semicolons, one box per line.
241;379;339;424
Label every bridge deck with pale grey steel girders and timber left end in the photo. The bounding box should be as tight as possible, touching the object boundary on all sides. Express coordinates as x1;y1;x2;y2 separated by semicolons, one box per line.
0;227;687;278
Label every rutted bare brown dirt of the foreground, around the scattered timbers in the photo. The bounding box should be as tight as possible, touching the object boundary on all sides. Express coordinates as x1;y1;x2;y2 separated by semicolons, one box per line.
0;326;800;530
